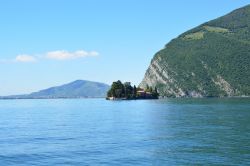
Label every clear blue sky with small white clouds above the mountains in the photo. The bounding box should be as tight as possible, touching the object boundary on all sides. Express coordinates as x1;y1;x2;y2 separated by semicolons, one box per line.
0;0;250;95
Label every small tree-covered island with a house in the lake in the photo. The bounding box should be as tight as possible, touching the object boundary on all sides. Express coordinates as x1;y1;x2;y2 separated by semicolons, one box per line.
106;80;159;100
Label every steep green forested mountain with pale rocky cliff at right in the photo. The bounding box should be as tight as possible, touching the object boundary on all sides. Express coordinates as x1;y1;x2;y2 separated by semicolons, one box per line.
140;5;250;97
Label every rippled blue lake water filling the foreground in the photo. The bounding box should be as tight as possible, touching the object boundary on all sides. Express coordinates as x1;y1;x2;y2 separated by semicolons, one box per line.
0;98;250;166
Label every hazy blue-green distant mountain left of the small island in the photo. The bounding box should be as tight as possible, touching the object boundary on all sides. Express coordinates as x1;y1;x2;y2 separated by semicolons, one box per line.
1;80;110;99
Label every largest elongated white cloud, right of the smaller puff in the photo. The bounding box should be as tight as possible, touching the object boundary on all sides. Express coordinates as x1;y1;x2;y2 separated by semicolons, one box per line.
45;50;99;60
